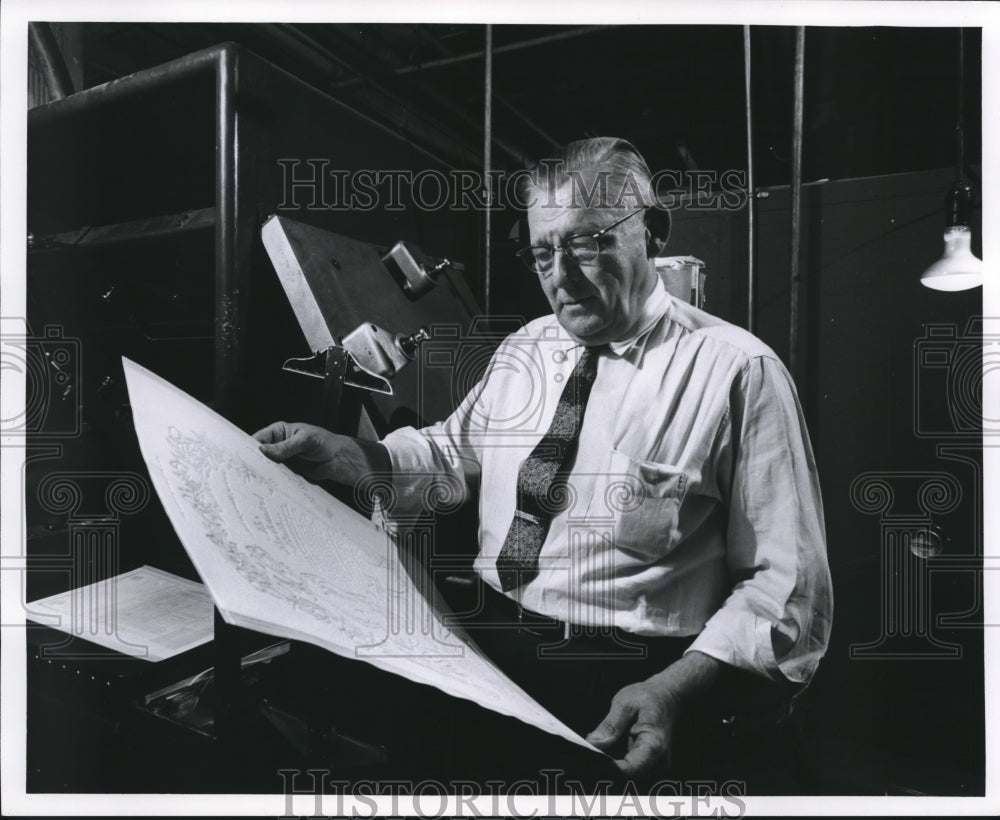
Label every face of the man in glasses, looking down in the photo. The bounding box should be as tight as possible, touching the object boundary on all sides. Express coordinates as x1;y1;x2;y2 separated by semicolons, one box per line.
528;174;656;345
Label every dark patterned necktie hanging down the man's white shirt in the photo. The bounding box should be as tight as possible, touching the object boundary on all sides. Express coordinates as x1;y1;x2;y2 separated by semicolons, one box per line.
497;347;602;592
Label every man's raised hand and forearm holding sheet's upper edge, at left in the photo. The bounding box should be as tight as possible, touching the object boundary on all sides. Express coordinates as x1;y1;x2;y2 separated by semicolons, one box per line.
253;421;392;485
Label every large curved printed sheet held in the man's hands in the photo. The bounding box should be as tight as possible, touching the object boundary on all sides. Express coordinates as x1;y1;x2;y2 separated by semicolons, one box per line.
123;359;597;751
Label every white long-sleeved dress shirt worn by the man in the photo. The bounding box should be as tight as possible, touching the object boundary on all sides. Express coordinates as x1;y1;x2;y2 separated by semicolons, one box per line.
383;280;833;682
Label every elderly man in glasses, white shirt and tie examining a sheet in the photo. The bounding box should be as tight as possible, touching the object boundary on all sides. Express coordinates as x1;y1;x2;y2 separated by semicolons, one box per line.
257;138;832;774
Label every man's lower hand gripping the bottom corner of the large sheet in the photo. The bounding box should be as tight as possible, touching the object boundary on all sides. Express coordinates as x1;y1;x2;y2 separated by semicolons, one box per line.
587;652;721;775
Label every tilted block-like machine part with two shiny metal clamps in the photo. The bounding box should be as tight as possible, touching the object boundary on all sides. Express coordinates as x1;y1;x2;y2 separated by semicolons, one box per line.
261;216;478;438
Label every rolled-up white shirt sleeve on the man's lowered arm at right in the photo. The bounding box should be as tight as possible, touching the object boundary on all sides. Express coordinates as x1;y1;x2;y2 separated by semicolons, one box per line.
688;356;833;683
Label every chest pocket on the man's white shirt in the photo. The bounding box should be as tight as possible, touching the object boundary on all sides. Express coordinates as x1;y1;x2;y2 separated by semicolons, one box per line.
590;450;687;563
